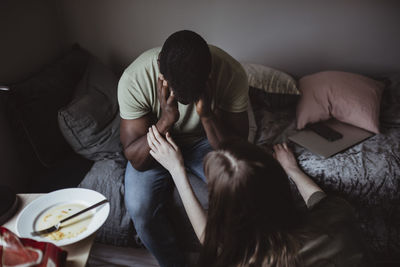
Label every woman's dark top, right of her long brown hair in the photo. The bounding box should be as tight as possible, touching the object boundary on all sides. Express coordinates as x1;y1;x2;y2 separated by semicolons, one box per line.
299;191;373;267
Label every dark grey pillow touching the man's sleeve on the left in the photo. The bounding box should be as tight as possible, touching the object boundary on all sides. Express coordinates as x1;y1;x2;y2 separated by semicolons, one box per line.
58;57;123;161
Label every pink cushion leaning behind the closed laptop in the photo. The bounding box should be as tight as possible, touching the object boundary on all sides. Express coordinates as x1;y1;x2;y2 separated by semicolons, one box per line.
297;71;384;133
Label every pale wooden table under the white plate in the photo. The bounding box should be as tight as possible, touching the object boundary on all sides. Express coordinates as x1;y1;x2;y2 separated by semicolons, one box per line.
2;194;96;267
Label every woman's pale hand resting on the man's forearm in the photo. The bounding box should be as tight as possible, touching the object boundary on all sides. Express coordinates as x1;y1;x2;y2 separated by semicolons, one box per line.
147;125;183;173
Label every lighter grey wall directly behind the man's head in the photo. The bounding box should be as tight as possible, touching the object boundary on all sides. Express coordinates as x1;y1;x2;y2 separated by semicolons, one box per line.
60;0;400;76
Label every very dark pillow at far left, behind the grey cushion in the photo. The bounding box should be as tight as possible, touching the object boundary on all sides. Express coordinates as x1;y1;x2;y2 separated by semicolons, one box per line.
7;46;88;167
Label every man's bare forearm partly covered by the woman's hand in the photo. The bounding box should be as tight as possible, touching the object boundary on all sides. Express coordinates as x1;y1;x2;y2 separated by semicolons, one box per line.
124;120;170;171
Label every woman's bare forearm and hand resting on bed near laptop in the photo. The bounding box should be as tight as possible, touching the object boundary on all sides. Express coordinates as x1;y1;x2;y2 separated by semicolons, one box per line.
274;143;323;203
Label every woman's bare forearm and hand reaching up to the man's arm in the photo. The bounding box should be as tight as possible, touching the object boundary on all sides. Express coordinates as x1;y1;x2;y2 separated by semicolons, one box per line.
147;126;207;243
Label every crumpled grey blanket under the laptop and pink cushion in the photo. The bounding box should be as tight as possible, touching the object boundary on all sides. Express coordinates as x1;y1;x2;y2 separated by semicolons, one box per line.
253;75;400;258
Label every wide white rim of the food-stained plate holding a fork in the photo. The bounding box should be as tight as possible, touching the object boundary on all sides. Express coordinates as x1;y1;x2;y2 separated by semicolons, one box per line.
16;188;110;246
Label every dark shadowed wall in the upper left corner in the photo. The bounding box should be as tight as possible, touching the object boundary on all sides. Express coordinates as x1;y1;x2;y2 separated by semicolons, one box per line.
0;0;65;84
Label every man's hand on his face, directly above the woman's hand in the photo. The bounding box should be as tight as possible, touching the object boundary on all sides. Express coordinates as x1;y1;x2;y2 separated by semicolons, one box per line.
157;75;179;131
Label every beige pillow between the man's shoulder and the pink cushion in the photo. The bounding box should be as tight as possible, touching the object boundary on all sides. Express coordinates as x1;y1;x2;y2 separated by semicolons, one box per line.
242;63;300;111
